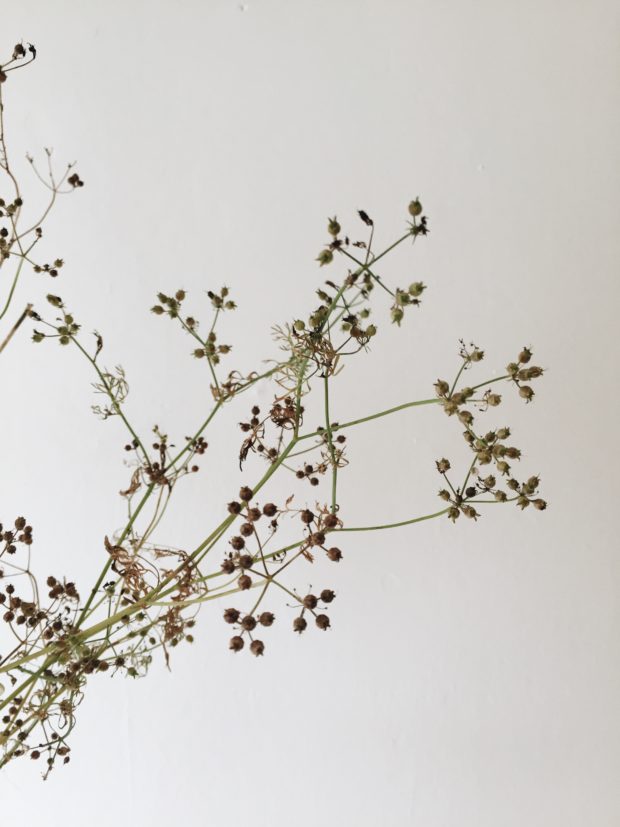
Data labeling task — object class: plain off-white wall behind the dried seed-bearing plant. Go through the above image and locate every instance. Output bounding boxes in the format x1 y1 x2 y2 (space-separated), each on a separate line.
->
0 0 620 827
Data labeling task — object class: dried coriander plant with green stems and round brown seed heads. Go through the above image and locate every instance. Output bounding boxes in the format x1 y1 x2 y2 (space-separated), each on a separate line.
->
0 44 546 776
